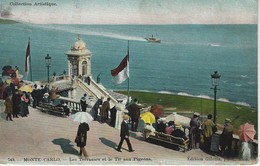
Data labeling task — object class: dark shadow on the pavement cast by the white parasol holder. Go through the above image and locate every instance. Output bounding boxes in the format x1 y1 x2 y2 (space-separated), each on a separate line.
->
52 138 79 155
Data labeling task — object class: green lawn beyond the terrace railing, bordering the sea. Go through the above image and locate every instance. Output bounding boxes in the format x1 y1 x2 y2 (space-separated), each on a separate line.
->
118 91 257 130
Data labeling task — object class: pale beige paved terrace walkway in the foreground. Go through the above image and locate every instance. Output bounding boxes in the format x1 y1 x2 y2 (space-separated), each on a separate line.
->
0 106 256 165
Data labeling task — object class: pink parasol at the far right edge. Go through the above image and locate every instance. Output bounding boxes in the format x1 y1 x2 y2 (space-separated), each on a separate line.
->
239 123 256 142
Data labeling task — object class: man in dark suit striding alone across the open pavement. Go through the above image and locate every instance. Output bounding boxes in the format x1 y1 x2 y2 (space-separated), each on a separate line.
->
116 115 134 152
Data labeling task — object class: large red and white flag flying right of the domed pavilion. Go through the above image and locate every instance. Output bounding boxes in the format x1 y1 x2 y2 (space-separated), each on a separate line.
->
111 55 129 84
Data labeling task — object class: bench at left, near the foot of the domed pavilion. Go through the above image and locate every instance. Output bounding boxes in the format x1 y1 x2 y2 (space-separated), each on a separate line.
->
39 102 65 117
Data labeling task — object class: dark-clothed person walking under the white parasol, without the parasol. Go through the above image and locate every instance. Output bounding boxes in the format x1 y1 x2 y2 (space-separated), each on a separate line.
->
75 122 89 157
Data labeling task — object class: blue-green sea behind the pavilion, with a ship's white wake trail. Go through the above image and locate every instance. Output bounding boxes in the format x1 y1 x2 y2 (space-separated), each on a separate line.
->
0 23 257 108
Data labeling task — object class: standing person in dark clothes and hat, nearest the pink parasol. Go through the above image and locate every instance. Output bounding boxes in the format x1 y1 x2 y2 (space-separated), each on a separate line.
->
220 118 234 157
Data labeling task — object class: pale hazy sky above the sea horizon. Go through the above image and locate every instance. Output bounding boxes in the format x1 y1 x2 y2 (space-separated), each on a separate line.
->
0 0 258 24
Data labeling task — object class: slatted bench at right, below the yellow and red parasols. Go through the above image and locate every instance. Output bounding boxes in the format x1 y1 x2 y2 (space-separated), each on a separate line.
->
144 129 189 152
